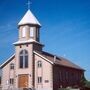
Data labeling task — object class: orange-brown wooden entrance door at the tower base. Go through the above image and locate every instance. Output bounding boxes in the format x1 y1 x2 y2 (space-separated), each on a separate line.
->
18 75 28 88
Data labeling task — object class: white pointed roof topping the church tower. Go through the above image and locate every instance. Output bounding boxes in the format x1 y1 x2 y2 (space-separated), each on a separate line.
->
18 10 41 26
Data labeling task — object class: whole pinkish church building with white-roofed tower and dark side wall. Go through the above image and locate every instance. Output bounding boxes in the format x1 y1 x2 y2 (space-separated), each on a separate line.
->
0 10 84 90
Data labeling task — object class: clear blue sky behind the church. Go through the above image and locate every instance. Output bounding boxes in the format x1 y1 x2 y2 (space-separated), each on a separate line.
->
0 0 90 80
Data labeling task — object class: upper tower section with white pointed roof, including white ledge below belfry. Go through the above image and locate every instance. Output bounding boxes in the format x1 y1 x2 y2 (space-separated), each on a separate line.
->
14 9 43 49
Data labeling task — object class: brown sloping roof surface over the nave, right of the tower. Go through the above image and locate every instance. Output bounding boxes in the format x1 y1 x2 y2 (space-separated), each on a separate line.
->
34 51 84 71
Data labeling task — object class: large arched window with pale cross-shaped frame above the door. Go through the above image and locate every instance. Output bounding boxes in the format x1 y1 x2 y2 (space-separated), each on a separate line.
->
19 50 28 68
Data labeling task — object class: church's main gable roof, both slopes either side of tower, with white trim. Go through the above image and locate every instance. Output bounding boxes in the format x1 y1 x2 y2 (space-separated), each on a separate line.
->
0 51 84 71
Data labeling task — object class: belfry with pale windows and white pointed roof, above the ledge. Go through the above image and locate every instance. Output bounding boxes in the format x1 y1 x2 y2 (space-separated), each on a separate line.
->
18 10 41 42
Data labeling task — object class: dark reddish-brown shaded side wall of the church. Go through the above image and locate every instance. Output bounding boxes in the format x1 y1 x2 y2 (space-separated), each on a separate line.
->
53 65 83 90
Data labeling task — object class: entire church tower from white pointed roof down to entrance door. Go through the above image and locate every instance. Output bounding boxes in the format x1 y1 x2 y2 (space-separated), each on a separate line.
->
14 9 43 88
